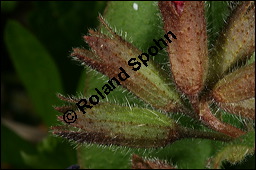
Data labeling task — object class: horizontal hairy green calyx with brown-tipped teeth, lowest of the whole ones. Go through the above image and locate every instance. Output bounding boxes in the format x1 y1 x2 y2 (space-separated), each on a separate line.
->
53 103 179 148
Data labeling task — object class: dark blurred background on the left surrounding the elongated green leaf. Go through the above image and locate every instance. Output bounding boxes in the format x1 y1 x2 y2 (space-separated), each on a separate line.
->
1 1 106 168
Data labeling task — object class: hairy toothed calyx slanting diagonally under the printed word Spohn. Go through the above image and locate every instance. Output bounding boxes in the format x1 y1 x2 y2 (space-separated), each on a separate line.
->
71 15 182 111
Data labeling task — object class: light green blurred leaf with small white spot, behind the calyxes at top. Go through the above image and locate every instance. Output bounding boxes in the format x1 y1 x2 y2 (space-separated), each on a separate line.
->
103 1 169 65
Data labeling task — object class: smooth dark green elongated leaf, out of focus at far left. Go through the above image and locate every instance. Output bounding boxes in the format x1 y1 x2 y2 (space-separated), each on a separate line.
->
5 20 62 126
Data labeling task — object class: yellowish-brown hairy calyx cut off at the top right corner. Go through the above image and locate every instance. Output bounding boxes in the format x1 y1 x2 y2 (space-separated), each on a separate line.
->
209 1 255 82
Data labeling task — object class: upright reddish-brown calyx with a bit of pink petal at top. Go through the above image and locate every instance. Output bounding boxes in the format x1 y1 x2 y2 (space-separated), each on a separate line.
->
159 1 208 96
